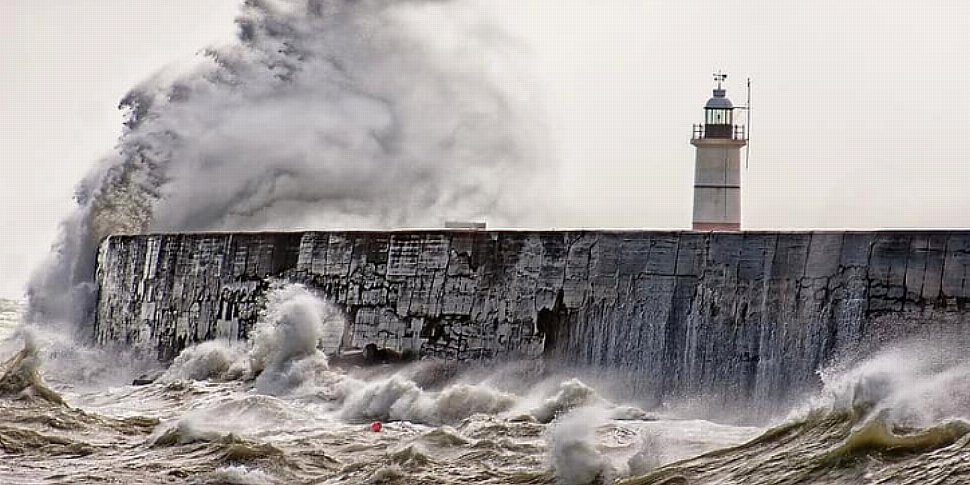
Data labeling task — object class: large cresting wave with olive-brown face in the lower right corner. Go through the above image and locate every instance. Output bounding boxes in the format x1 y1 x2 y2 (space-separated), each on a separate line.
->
623 342 970 485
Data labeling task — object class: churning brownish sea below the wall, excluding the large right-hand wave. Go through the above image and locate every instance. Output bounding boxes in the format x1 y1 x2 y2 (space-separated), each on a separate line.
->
0 289 760 484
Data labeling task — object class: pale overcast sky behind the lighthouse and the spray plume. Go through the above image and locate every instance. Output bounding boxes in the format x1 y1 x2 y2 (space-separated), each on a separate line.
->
0 0 970 296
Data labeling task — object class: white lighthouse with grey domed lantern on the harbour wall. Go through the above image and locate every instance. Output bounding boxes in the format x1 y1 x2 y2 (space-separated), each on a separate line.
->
690 73 748 231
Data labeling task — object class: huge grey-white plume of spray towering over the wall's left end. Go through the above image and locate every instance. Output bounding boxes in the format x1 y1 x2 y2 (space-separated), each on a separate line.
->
28 0 545 323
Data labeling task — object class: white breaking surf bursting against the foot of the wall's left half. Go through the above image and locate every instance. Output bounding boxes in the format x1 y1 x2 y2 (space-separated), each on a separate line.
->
160 285 516 424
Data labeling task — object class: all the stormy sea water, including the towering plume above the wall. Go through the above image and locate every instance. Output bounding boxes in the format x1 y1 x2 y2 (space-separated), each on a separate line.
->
9 0 970 485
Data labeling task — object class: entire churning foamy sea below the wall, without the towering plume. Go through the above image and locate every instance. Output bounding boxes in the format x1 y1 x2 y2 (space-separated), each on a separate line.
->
0 288 970 485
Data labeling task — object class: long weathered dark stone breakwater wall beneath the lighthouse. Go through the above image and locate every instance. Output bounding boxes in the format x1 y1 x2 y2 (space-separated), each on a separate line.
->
94 230 970 402
